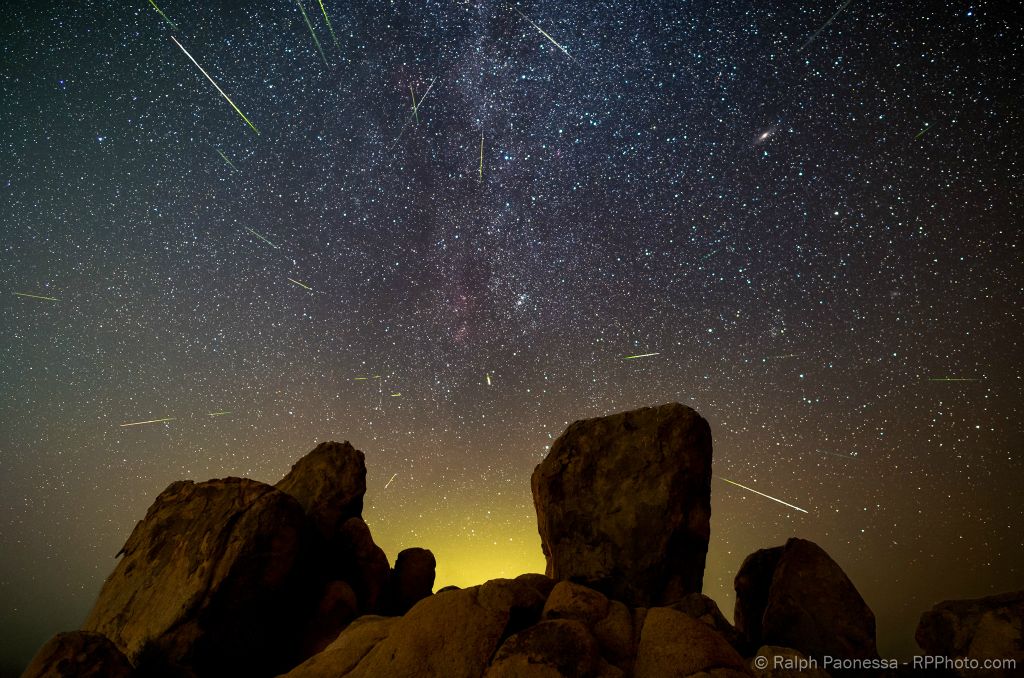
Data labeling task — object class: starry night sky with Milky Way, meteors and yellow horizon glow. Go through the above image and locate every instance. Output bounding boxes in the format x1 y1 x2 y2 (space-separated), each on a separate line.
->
0 0 1024 672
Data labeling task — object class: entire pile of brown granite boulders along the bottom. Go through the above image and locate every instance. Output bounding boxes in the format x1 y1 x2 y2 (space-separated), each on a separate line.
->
24 404 1024 678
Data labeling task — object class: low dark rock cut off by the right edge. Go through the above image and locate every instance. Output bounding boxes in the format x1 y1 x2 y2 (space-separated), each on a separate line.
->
915 591 1024 676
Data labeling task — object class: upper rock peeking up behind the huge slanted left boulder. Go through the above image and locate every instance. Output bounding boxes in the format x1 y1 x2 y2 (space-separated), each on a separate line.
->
274 441 367 542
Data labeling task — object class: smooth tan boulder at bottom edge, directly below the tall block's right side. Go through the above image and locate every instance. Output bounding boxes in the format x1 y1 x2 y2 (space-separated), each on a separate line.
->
633 607 748 678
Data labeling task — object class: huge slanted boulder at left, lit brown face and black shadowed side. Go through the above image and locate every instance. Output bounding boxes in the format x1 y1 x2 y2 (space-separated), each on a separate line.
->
84 478 309 676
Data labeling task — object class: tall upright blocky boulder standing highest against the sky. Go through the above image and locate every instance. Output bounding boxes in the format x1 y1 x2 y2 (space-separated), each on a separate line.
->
531 402 712 606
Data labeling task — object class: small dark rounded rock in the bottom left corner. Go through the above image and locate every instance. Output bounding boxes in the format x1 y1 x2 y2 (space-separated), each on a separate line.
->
22 631 135 678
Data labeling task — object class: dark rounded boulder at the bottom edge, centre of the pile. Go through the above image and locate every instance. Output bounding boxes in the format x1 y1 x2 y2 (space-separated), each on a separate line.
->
483 620 602 678
